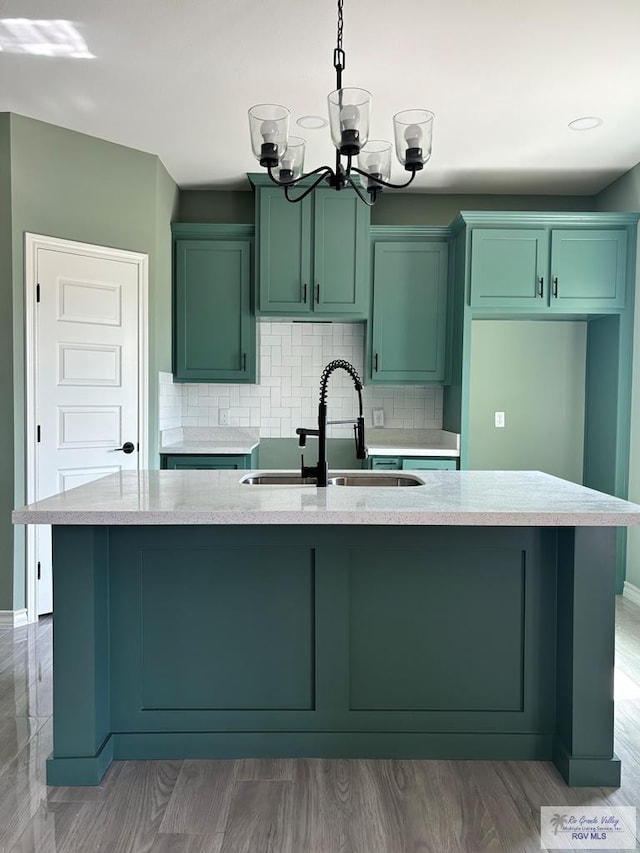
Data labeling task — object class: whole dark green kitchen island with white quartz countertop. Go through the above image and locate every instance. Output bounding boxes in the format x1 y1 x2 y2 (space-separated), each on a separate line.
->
13 471 640 786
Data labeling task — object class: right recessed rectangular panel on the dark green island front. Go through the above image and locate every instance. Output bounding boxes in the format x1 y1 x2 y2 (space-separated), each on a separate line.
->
349 546 525 712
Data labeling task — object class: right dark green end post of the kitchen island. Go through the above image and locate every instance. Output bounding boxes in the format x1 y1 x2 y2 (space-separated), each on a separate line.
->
554 527 620 787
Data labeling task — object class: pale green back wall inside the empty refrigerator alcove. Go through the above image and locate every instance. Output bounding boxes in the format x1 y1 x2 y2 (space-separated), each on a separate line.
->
469 320 586 483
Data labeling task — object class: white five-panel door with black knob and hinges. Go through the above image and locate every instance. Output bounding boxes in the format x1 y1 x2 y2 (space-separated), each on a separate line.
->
30 236 148 615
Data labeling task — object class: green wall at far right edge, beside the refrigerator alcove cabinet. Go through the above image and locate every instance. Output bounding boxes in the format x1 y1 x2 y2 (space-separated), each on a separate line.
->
596 163 640 589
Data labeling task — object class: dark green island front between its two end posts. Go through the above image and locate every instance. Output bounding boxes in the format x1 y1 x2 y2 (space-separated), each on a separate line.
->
106 525 556 744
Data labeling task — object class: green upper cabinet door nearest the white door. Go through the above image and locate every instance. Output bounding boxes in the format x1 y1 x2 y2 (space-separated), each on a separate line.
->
174 240 255 382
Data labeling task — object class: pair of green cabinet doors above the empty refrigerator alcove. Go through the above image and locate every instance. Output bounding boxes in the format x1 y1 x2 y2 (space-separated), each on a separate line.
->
470 227 627 314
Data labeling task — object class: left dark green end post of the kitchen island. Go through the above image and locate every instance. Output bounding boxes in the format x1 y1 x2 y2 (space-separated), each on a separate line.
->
47 526 113 785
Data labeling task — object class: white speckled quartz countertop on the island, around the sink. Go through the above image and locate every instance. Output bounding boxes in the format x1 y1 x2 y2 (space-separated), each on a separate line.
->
13 470 640 527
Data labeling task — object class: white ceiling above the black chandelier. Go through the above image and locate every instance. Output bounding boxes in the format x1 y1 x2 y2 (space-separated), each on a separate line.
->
0 0 640 194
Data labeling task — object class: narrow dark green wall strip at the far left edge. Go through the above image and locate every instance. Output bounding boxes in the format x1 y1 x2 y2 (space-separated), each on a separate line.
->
0 113 14 610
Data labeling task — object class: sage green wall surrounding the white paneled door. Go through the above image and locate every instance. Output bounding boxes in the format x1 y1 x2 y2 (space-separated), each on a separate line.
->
0 114 177 610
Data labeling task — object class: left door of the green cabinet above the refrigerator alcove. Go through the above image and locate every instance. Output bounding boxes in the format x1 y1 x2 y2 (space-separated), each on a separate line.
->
471 228 549 309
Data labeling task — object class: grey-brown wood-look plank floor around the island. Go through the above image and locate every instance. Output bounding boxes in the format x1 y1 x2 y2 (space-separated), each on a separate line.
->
0 599 640 853
